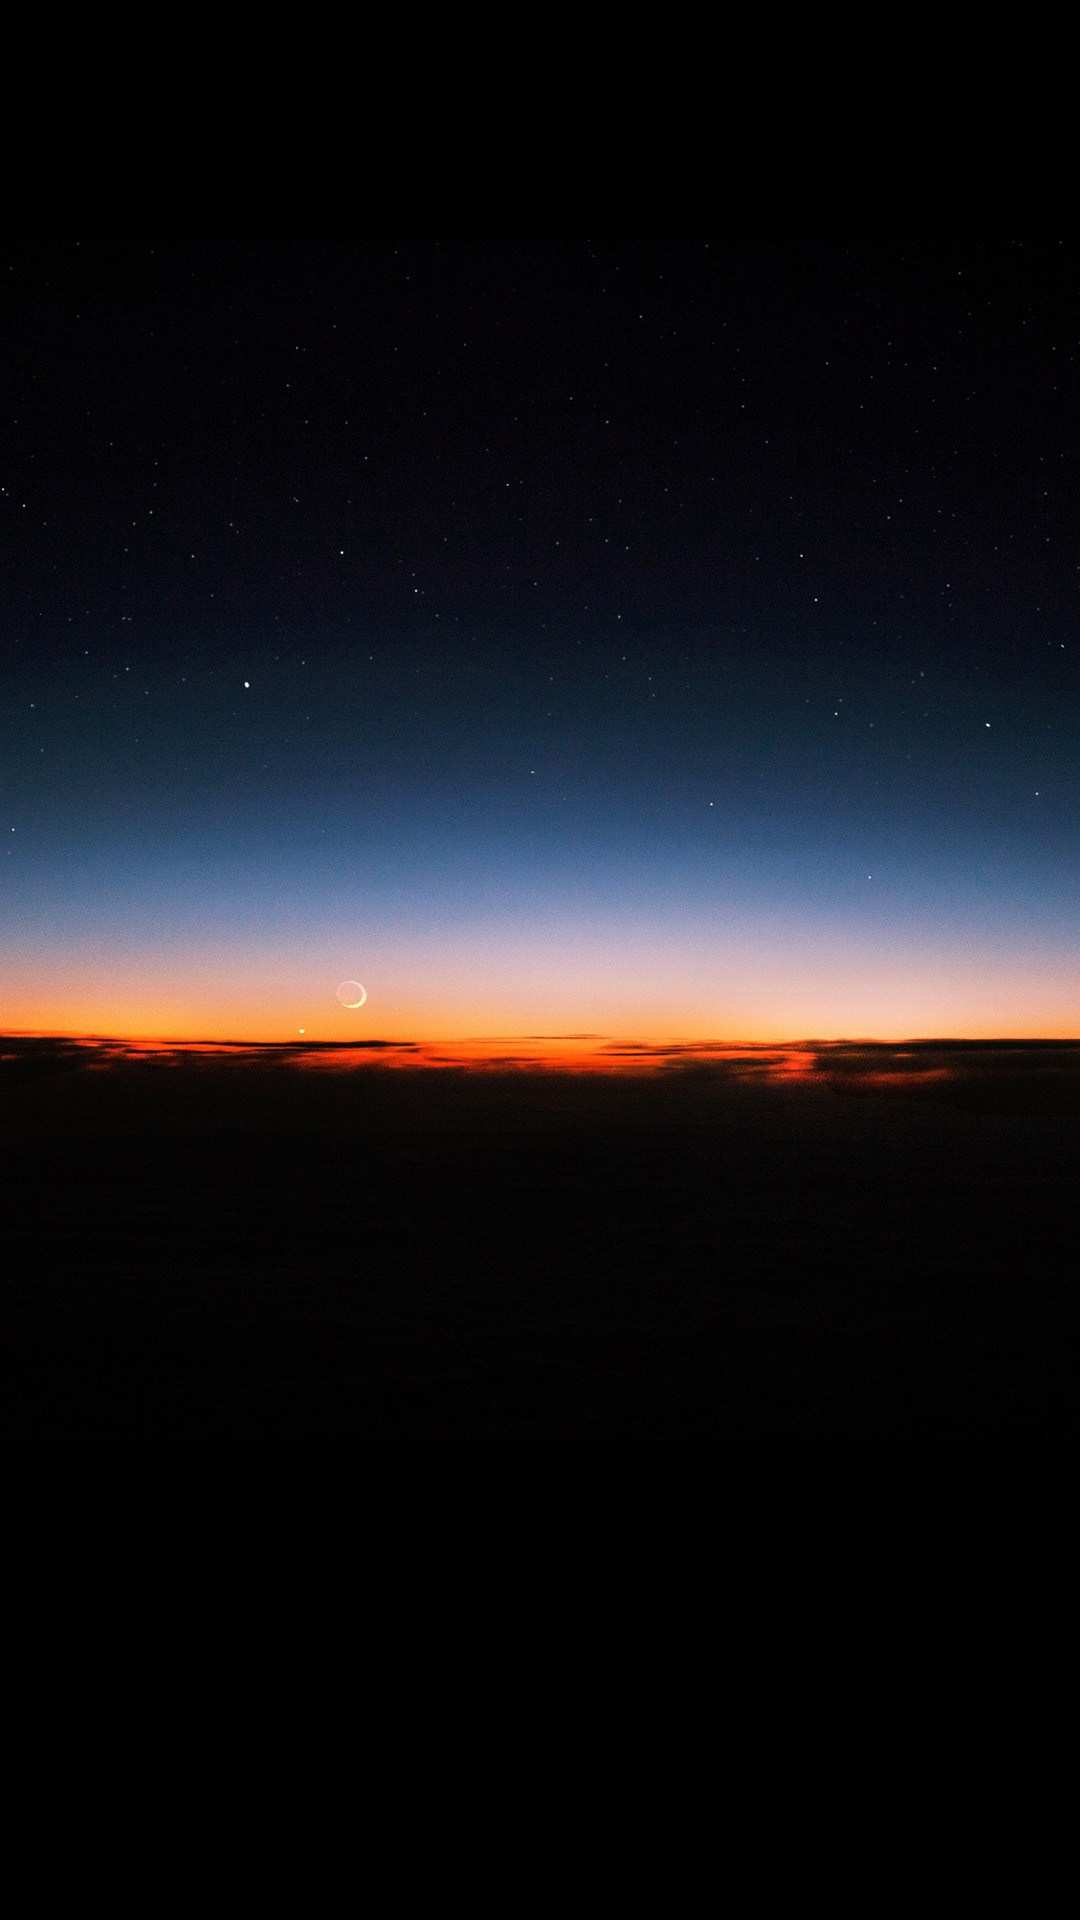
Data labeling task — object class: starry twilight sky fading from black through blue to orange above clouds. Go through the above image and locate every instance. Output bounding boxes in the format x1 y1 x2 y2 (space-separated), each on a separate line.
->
0 245 1080 1041
